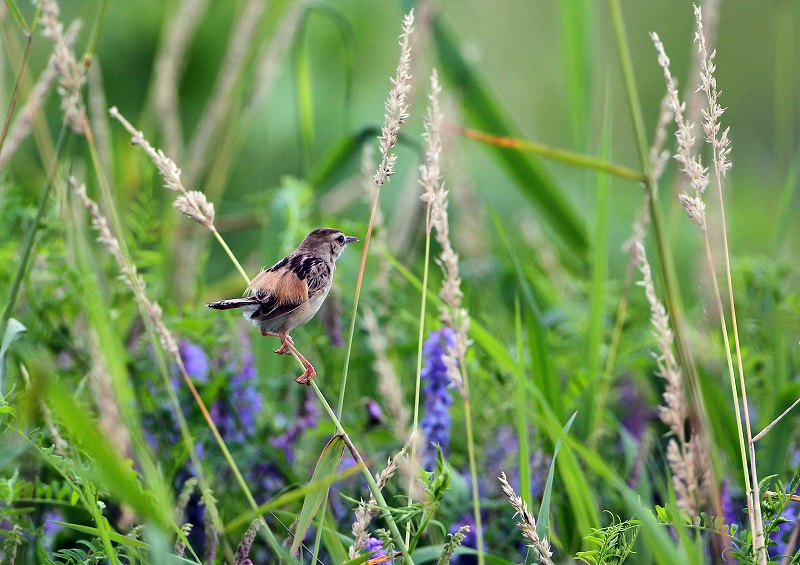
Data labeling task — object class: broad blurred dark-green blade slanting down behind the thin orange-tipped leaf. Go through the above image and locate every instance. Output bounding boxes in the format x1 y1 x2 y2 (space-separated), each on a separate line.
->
433 18 589 259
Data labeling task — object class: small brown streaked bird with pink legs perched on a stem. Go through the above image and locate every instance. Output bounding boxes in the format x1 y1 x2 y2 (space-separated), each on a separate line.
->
206 228 358 385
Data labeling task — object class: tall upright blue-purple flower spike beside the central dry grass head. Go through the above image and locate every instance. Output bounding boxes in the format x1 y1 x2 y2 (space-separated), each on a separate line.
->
420 328 455 469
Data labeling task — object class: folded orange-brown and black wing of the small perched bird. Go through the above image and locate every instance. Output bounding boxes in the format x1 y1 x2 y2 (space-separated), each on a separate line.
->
245 255 309 320
